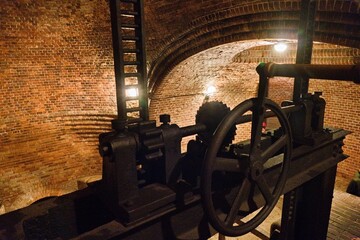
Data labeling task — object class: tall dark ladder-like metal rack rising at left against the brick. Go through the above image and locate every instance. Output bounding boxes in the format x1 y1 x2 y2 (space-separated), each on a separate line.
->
110 0 149 130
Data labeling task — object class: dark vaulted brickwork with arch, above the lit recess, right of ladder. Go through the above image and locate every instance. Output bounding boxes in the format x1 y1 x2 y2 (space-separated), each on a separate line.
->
144 0 360 92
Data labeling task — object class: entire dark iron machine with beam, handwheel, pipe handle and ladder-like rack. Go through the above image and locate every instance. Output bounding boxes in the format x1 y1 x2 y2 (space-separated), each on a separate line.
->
0 0 360 240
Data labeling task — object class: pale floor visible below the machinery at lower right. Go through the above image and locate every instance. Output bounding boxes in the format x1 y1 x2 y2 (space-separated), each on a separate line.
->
210 174 360 240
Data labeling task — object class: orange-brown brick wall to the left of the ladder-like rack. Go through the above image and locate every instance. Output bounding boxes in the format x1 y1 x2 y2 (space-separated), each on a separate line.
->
0 0 115 211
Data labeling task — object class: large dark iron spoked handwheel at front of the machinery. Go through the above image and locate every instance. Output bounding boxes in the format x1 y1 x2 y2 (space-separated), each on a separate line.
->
201 98 292 236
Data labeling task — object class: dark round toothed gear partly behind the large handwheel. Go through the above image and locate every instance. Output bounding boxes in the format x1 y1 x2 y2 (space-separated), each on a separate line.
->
195 101 236 146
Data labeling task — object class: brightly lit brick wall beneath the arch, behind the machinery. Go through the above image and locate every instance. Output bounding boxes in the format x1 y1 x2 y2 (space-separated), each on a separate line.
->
149 41 360 180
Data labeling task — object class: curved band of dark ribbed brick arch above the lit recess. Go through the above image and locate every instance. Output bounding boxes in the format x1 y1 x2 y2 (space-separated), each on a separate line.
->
149 0 360 93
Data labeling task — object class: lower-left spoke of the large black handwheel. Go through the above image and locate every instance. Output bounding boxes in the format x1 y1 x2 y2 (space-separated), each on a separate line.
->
225 178 251 226
